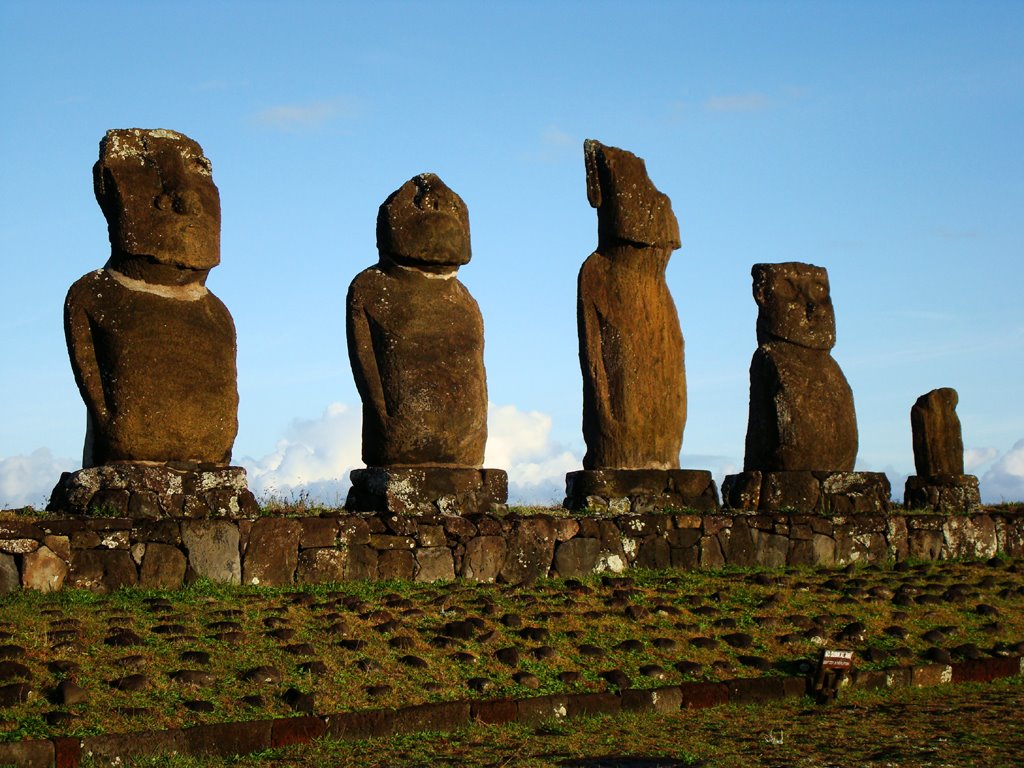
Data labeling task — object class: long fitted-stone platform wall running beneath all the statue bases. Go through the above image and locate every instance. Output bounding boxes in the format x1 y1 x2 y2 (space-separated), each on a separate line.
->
0 511 1024 592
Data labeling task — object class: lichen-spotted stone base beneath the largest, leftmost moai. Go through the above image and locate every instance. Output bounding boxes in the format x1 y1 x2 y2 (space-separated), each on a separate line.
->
46 462 259 519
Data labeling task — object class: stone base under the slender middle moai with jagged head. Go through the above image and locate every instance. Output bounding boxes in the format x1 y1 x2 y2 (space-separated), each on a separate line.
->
562 469 719 514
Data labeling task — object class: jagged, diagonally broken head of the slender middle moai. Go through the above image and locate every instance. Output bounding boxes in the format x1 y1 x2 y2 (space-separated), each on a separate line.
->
583 138 679 251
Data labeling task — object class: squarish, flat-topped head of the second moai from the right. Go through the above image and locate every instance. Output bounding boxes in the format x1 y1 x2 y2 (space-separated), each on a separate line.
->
751 261 836 349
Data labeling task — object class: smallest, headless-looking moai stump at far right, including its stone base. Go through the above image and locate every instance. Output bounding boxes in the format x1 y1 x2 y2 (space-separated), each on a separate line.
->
903 387 981 512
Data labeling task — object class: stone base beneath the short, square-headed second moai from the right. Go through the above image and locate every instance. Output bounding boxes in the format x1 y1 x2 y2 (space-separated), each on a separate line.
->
722 470 892 515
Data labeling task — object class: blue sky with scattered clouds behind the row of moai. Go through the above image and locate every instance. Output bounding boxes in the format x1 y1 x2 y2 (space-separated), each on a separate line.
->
0 0 1024 506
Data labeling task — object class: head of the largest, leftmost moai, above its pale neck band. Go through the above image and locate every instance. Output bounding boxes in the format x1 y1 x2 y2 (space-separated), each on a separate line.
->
92 128 220 282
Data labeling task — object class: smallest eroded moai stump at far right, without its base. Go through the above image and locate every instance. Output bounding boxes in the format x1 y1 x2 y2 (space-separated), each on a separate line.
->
910 387 964 476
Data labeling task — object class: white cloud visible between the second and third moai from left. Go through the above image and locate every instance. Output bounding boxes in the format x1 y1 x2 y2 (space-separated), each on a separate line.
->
483 403 583 506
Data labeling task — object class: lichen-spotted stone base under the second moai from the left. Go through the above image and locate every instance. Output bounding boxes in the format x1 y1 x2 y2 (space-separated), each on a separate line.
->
345 467 509 515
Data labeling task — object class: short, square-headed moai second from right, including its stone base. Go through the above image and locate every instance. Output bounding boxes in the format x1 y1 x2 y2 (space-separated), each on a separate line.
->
723 261 890 512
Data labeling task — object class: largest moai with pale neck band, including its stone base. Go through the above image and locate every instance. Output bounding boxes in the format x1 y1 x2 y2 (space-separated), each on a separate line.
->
51 128 255 516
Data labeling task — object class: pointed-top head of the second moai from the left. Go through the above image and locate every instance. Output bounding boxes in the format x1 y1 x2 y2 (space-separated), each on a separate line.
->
377 173 471 272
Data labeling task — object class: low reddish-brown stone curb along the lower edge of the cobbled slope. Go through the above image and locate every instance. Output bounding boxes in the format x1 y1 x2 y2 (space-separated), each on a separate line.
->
0 656 1024 768
